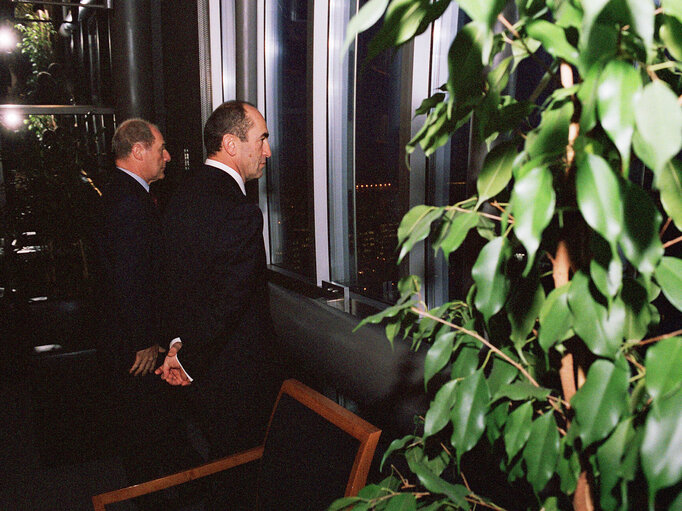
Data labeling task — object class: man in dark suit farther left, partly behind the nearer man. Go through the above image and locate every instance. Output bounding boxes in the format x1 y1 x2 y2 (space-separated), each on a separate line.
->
94 119 183 498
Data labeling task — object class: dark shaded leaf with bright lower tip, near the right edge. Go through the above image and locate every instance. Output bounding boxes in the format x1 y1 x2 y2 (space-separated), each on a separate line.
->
620 180 660 276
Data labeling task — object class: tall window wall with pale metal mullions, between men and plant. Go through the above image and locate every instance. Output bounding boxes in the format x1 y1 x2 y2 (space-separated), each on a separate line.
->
227 0 478 305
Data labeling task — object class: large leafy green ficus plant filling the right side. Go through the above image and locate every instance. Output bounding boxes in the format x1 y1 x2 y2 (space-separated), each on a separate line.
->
331 0 682 511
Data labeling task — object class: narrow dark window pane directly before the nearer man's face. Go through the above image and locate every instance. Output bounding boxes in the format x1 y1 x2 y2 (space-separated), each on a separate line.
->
265 0 315 278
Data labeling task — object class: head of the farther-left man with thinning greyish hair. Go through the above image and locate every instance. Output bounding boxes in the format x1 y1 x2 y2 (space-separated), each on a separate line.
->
111 119 170 183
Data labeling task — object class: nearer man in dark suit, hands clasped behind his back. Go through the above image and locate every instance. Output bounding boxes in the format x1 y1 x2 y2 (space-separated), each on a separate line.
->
156 101 281 457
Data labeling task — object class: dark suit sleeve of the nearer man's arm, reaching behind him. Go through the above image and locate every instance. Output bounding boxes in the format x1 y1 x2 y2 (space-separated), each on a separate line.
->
166 204 264 377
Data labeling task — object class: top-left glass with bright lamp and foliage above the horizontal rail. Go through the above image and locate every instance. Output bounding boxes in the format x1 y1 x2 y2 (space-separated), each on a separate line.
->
0 3 111 105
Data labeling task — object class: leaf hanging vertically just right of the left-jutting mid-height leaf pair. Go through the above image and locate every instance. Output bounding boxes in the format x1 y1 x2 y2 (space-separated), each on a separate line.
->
471 238 509 321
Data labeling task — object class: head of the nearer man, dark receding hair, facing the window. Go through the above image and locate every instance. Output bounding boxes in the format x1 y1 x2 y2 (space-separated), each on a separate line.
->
204 101 272 182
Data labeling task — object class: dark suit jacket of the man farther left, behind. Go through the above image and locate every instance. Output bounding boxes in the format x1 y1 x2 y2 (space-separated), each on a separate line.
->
94 169 167 371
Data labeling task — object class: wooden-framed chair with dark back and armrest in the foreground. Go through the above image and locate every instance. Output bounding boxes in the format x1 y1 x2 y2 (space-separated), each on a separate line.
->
92 379 381 511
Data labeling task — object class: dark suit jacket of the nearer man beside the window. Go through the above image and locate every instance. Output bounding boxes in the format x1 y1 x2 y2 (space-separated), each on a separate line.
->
163 165 273 378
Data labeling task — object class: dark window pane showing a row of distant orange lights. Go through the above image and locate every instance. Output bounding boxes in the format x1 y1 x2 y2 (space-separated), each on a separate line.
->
351 2 408 302
